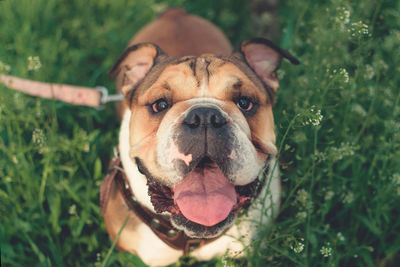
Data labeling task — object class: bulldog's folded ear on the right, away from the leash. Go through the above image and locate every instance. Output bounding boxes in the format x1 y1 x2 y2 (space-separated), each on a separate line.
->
240 38 300 92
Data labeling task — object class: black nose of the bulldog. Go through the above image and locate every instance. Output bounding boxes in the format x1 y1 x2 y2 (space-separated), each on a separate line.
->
183 107 227 129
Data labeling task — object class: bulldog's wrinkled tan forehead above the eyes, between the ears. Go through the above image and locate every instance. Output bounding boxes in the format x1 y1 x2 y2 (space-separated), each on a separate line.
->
135 54 270 101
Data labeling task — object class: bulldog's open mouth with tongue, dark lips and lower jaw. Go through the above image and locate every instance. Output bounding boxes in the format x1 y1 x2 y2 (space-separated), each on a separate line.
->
142 157 261 238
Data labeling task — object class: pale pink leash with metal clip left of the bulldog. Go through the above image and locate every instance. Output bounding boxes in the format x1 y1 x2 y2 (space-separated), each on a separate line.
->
0 74 124 107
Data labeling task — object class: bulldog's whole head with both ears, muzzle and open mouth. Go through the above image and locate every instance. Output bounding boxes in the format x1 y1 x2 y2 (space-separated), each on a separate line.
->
112 39 296 238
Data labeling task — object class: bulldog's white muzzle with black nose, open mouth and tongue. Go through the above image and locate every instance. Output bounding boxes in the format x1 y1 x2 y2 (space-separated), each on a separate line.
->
149 101 264 238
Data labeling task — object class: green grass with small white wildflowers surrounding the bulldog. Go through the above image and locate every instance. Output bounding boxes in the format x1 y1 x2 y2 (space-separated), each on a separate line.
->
0 0 400 266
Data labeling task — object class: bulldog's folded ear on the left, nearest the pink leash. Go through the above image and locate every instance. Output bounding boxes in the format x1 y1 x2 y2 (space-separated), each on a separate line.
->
108 43 164 96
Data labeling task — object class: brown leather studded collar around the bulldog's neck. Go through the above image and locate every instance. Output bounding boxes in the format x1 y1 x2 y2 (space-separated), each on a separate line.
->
100 157 221 255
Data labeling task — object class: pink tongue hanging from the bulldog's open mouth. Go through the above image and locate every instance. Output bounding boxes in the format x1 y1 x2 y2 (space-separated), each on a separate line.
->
174 166 236 226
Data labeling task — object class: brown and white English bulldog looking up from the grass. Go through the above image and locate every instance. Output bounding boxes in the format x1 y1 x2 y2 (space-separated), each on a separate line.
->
101 9 298 266
